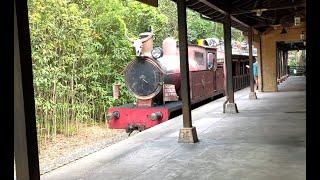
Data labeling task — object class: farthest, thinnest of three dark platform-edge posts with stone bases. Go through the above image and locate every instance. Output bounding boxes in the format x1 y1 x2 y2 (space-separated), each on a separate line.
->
248 27 257 99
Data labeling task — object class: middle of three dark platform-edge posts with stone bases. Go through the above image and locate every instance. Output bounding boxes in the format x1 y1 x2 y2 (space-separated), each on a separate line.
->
223 13 238 113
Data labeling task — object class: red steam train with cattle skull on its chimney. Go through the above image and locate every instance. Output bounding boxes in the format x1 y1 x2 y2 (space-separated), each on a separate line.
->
106 32 256 133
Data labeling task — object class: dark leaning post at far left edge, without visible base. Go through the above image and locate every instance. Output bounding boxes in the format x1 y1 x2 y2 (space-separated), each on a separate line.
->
14 1 40 180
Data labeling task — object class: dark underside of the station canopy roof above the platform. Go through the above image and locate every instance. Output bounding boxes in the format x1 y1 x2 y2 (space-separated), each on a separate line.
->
173 0 306 32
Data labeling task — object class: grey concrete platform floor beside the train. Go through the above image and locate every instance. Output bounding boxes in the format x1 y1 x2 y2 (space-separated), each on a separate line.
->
41 77 306 180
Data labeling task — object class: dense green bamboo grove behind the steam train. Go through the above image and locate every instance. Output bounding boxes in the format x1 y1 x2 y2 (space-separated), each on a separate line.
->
28 0 244 144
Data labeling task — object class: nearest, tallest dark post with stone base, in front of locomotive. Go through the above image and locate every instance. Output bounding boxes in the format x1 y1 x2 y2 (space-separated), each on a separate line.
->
177 0 198 143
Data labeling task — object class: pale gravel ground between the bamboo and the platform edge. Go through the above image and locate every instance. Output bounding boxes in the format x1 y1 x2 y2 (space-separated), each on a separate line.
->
14 126 138 179
